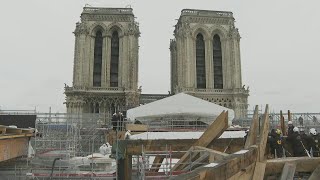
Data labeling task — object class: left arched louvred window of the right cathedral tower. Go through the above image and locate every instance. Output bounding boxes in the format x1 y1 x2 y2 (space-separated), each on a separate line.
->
196 33 206 89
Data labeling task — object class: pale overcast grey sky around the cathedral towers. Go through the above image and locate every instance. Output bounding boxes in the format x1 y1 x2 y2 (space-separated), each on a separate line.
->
0 0 320 112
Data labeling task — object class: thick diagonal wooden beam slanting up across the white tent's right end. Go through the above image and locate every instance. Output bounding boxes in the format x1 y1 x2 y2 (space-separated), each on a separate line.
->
172 111 228 171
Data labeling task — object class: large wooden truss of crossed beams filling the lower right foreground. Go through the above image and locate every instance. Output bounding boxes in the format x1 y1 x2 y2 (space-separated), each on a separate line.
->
172 105 320 180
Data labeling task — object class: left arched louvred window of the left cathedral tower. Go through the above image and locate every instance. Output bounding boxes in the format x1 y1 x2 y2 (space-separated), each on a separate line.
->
93 31 103 87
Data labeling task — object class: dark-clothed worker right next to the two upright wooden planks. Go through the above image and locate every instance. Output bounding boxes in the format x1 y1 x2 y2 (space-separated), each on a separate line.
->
269 129 283 158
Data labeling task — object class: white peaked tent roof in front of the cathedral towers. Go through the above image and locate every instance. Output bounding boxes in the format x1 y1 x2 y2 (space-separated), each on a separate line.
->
127 93 234 122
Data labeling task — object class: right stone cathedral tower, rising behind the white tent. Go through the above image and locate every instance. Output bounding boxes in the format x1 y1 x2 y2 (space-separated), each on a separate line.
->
170 9 249 118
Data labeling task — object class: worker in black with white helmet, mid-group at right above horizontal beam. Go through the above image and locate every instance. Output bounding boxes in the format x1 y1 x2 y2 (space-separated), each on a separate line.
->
287 127 309 157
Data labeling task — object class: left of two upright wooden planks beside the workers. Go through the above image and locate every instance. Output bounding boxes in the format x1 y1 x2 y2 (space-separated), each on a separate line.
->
244 105 259 148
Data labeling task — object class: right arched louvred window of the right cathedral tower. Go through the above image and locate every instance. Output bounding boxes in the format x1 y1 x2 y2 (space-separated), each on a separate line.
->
213 34 223 89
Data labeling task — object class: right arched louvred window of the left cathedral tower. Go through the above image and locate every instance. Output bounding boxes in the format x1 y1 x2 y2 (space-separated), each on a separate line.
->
110 31 119 87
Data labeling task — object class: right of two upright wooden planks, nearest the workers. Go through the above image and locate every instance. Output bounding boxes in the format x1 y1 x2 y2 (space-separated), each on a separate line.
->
257 104 270 162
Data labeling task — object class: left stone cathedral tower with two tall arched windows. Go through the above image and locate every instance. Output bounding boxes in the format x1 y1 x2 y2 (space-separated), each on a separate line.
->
65 7 140 114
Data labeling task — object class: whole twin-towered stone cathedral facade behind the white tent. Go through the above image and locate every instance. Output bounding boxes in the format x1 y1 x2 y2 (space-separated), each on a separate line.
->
65 7 249 118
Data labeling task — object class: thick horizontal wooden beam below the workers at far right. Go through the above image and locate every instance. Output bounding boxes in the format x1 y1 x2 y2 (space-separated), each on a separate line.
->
265 157 320 175
